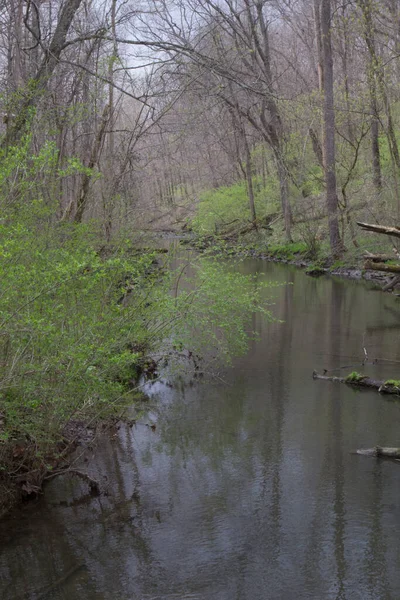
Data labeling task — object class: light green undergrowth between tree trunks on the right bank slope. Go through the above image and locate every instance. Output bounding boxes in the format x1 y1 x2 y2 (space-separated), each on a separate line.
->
186 126 400 270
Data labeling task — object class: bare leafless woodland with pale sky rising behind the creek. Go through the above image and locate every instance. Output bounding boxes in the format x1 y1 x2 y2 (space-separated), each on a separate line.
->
0 0 400 255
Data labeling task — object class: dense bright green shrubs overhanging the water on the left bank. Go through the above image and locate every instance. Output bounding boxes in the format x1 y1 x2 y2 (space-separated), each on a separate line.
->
0 138 276 509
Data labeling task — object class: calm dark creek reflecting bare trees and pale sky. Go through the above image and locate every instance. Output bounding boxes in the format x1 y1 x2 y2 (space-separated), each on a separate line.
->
0 259 400 600
